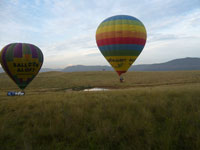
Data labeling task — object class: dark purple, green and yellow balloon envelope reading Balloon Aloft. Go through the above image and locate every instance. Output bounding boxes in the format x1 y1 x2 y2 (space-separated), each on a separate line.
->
0 43 43 90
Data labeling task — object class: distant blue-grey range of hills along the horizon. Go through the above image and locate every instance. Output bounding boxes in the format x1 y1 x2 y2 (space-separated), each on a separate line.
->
0 57 200 73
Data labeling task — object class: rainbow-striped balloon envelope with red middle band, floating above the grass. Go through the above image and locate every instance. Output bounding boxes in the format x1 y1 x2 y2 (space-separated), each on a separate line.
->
96 15 147 76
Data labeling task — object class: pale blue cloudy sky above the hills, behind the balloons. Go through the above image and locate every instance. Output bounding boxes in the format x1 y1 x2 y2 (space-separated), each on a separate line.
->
0 0 200 68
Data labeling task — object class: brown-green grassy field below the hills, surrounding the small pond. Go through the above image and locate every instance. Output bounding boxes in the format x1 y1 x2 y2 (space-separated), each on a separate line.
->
0 71 200 150
